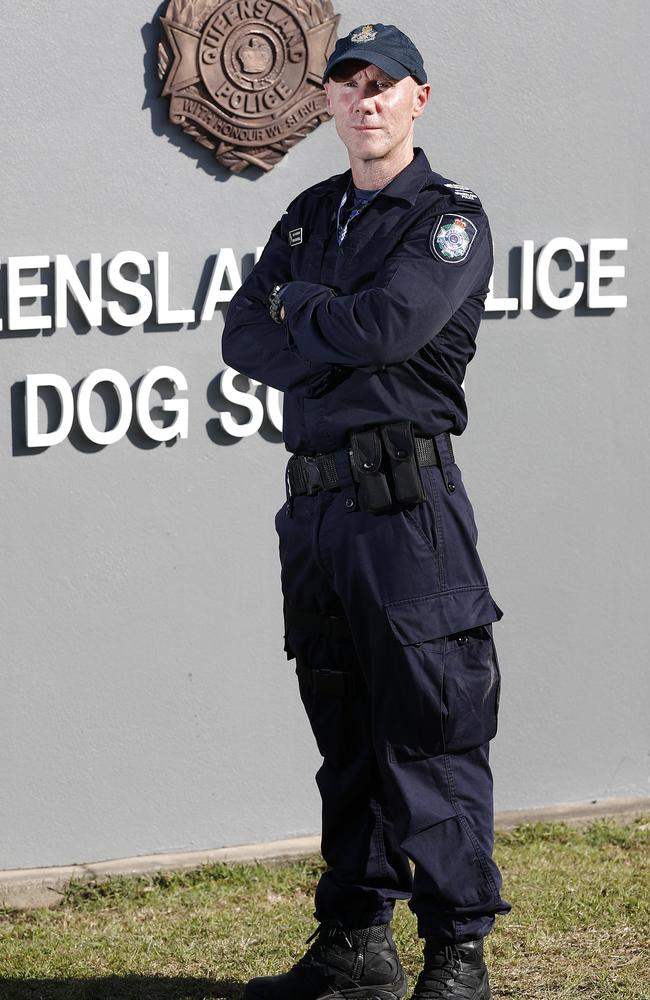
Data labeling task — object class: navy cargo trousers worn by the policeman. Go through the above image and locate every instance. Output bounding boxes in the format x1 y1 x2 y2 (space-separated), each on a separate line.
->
275 435 510 943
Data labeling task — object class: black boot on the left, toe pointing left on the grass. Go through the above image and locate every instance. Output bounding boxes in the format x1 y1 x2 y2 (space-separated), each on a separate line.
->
244 921 406 1000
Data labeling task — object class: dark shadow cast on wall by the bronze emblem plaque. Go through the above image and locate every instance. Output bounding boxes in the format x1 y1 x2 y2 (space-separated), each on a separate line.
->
141 0 264 181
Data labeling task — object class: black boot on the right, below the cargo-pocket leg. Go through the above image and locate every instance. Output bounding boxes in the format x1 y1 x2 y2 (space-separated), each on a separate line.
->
413 940 492 1000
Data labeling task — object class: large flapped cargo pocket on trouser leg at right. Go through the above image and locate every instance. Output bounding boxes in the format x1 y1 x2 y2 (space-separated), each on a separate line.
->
385 587 502 761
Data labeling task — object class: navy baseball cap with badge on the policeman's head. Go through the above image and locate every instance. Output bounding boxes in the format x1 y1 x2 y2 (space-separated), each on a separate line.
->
323 24 427 83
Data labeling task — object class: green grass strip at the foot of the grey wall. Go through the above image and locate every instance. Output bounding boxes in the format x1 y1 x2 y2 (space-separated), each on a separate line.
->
0 817 650 1000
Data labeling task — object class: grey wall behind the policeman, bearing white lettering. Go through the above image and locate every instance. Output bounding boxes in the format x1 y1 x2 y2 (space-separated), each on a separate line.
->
0 0 650 868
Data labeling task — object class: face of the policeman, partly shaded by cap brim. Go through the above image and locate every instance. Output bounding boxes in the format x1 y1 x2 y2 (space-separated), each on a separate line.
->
325 60 430 160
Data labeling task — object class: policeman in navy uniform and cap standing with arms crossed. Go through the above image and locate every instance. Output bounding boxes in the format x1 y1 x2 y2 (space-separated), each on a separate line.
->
223 24 509 1000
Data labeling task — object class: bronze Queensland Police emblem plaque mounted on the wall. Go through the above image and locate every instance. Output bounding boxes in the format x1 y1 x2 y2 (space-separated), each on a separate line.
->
158 0 339 173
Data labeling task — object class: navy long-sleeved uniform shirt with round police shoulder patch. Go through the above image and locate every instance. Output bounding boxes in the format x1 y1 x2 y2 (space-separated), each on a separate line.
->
223 149 493 455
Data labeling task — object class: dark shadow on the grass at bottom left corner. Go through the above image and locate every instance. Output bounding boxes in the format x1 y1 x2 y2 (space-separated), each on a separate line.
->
0 975 245 1000
